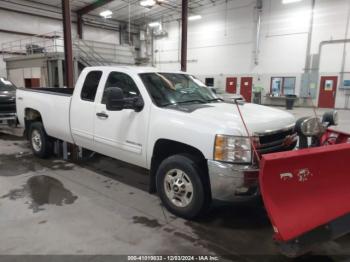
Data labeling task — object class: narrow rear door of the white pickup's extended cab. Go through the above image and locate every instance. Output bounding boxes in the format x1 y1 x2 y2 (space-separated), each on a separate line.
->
69 70 102 150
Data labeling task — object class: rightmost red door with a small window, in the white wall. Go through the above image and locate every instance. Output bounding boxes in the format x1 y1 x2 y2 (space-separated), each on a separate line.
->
318 76 338 108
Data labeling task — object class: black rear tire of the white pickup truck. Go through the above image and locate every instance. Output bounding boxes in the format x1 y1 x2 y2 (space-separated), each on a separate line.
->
29 122 53 158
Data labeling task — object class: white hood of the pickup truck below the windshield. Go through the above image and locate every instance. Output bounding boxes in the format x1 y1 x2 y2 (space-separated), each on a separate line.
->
167 103 296 135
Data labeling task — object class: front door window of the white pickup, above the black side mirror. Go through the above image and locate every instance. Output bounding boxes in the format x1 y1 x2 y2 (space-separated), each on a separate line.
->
101 72 140 104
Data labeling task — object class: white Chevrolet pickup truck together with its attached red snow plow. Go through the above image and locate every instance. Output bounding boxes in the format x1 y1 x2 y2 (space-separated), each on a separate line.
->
16 66 350 256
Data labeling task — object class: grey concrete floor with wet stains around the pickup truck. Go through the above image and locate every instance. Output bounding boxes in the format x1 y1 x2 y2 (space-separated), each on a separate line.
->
0 108 350 261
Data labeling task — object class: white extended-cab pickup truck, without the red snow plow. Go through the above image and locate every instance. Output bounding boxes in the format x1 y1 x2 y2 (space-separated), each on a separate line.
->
16 66 297 218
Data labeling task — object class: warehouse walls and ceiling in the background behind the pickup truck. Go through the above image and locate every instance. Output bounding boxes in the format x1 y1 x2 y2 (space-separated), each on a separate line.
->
0 0 350 109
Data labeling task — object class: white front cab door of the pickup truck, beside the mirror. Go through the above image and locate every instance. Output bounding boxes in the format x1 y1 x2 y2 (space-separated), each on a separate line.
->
94 71 149 167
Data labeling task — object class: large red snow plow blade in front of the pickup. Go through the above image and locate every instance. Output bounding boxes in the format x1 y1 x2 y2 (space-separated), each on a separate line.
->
260 134 350 256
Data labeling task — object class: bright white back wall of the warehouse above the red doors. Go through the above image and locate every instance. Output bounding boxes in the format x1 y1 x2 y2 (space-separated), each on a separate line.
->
155 0 350 108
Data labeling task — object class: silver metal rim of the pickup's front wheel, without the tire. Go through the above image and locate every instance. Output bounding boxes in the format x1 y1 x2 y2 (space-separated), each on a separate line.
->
164 169 193 207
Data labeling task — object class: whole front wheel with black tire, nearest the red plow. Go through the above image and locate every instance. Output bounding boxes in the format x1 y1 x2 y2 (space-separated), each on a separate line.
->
156 155 210 219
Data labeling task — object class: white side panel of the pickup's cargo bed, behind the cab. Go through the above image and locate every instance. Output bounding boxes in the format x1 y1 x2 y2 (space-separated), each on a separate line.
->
16 88 74 143
